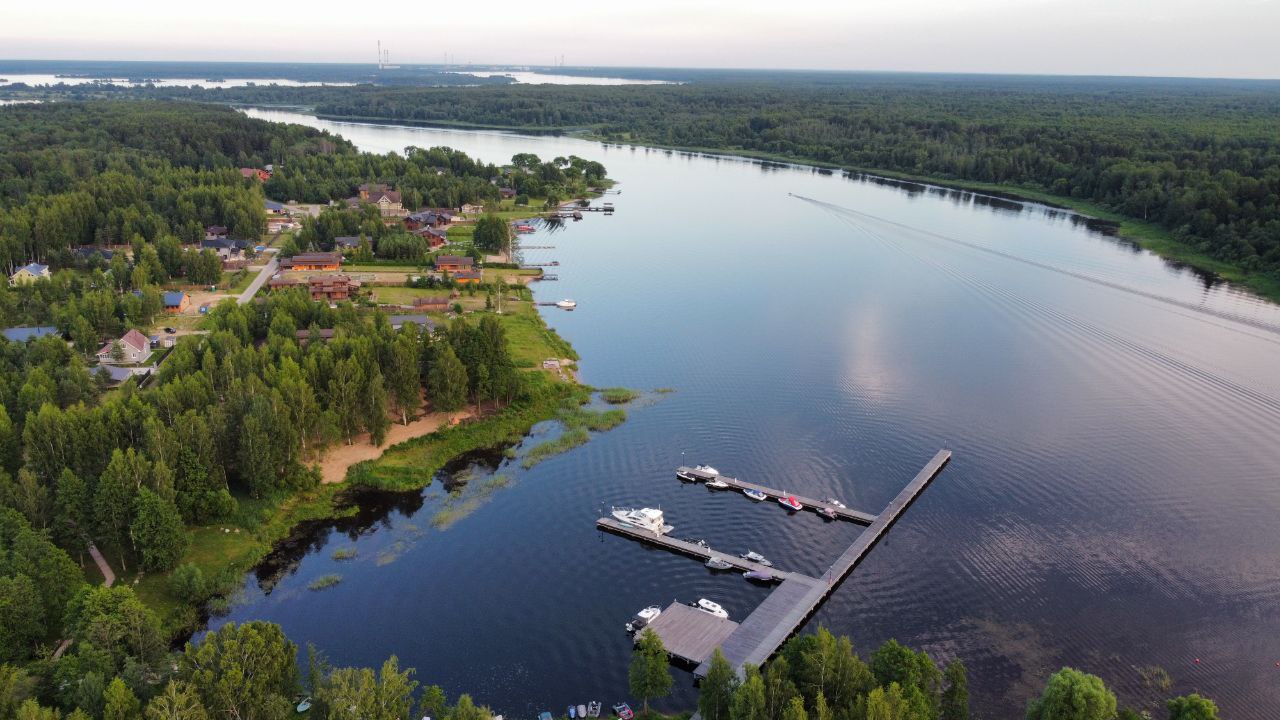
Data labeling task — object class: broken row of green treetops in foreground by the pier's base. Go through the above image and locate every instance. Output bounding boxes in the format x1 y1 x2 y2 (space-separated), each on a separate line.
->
628 628 1217 720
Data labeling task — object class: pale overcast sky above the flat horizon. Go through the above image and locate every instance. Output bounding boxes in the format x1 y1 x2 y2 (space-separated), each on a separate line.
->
0 0 1280 78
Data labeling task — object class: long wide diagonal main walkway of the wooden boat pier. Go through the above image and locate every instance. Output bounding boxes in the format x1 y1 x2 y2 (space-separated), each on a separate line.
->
694 450 951 678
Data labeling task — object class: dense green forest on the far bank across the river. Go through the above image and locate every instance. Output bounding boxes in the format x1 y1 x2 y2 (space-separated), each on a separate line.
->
42 73 1280 292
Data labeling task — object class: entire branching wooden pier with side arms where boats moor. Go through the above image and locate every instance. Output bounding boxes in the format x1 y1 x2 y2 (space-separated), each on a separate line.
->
595 450 951 678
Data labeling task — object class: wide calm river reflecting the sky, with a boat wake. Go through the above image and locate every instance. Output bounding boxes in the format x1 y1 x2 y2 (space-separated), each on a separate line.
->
214 110 1280 719
